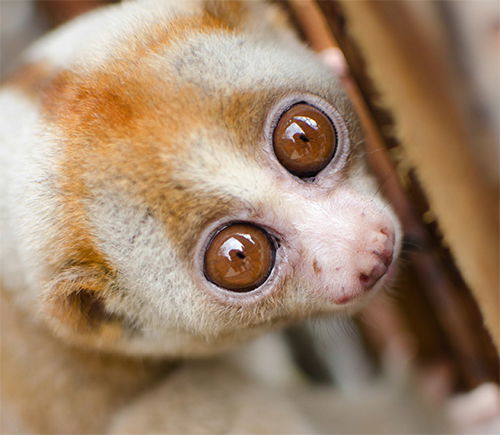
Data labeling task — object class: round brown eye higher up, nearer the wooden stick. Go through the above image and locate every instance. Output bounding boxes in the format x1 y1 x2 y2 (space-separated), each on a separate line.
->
273 103 336 177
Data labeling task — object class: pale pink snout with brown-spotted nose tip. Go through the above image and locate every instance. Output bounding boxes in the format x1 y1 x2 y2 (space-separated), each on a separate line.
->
280 187 401 308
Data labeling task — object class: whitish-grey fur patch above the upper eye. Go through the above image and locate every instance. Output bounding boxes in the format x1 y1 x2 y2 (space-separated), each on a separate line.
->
158 32 335 95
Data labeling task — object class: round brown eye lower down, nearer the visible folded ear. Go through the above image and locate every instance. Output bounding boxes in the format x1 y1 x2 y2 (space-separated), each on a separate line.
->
204 224 274 292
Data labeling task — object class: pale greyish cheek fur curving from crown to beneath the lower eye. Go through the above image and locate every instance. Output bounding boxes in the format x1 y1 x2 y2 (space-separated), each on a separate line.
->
87 192 279 353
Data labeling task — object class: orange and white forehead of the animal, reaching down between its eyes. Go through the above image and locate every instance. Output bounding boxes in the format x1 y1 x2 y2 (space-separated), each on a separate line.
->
37 3 357 268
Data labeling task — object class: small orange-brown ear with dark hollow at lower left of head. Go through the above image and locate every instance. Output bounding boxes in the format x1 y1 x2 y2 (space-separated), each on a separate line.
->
42 265 122 341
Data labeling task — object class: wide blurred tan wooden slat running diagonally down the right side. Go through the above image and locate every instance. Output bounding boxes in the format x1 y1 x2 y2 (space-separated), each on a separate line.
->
339 0 500 345
